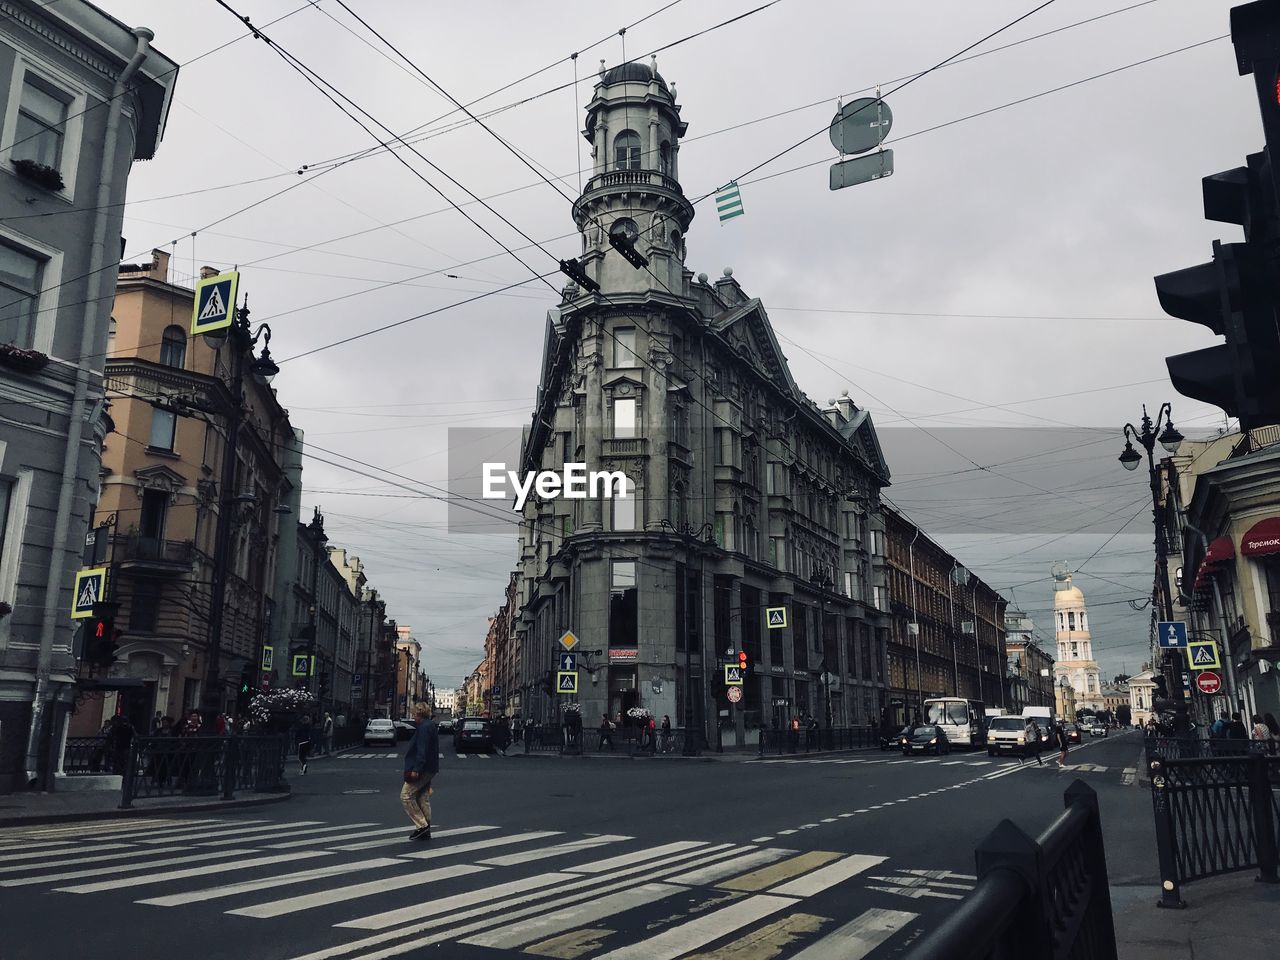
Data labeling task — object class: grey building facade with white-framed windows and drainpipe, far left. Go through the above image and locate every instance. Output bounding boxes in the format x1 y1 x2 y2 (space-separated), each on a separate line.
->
0 0 178 792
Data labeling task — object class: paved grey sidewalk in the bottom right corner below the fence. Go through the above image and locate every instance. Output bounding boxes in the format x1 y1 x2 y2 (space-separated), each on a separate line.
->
1111 870 1280 960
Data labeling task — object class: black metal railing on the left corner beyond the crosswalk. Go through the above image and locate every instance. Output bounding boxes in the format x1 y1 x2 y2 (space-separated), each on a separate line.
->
120 736 284 808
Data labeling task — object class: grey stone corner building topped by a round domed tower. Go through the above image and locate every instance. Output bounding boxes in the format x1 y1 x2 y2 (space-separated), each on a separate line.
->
504 63 890 744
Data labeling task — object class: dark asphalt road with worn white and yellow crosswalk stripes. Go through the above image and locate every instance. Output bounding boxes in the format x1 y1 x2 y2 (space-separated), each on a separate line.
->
0 733 1155 960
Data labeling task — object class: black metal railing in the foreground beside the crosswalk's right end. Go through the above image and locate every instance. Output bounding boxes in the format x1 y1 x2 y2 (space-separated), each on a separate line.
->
906 780 1116 960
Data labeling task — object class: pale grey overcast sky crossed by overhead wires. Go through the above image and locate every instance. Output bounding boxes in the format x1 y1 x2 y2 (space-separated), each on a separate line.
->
101 0 1262 686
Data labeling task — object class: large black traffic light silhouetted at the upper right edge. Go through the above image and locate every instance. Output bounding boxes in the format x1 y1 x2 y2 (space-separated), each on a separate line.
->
1155 0 1280 429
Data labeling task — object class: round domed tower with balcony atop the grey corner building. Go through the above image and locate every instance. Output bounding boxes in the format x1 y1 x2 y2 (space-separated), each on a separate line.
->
573 58 694 297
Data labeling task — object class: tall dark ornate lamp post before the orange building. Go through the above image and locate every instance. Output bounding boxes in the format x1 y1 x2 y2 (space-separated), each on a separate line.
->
204 298 280 722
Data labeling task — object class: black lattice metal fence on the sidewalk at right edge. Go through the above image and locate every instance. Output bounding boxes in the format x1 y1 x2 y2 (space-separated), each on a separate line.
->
1147 740 1280 908
